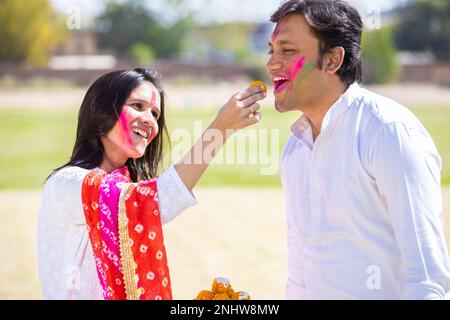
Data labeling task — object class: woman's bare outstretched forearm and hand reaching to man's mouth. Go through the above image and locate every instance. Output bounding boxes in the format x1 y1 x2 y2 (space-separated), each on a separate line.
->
175 86 266 190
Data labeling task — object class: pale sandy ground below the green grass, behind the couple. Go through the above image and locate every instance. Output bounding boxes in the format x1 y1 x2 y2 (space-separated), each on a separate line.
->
0 187 450 300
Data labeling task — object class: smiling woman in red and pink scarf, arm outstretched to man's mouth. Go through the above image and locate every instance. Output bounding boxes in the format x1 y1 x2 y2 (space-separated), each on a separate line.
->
38 69 265 299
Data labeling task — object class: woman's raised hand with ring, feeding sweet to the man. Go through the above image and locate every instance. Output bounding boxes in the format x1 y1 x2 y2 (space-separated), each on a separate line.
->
211 86 267 131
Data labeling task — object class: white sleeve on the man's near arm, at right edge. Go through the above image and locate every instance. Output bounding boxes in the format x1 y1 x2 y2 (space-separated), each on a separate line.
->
371 123 450 299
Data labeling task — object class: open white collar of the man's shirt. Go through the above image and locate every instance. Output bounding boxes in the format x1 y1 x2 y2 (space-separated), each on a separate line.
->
291 82 361 143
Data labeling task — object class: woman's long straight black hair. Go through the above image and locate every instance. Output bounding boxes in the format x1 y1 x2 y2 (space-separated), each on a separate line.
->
49 69 168 182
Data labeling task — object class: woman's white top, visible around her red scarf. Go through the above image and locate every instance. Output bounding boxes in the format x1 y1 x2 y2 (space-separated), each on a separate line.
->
37 166 196 300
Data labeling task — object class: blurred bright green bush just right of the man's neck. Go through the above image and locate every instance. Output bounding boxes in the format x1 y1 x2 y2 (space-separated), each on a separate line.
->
362 27 400 83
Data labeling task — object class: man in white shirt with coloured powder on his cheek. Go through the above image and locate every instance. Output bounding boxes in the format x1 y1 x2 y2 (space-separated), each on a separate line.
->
267 0 450 299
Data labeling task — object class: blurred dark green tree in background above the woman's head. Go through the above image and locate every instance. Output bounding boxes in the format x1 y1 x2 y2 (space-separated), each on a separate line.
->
96 0 193 59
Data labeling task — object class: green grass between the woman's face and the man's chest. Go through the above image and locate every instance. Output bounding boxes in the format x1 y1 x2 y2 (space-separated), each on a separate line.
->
168 110 299 187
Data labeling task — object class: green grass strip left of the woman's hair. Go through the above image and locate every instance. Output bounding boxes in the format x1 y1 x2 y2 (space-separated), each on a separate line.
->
0 110 76 189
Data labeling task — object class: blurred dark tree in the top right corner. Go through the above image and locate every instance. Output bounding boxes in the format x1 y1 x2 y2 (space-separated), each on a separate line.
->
394 0 450 61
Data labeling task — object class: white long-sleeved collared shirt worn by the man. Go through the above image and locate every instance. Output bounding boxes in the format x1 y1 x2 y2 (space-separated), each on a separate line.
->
281 84 450 299
